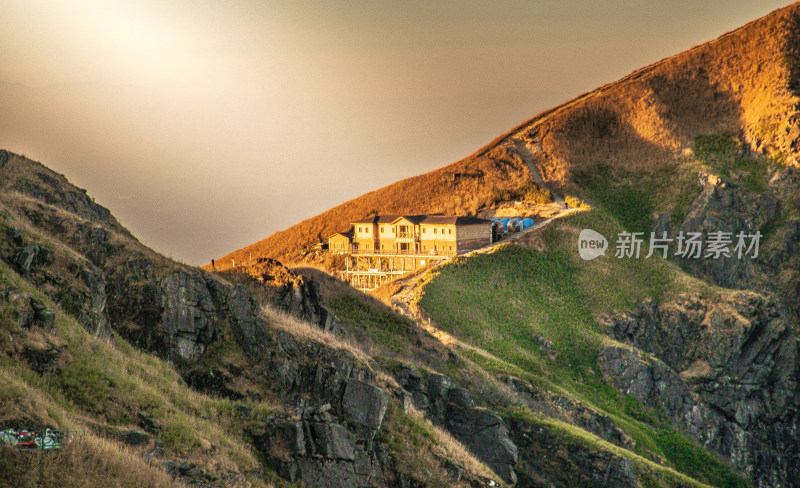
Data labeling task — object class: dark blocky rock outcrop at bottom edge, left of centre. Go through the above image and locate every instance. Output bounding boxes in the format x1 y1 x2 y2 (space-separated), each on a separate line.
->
251 331 390 488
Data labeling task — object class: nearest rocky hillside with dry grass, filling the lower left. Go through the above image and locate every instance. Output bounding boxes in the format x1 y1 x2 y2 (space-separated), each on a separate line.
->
0 151 507 487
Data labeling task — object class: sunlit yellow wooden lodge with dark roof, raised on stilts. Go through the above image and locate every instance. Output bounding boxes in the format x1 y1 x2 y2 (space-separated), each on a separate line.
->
328 215 493 290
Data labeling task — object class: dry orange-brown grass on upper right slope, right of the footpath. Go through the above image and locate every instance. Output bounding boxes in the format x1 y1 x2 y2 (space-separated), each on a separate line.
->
515 4 800 183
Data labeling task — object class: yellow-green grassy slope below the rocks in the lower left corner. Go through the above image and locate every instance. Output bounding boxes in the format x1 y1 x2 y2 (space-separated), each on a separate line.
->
0 262 278 486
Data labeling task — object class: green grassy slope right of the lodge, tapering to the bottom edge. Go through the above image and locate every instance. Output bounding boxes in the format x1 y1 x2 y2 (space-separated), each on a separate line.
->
419 210 743 486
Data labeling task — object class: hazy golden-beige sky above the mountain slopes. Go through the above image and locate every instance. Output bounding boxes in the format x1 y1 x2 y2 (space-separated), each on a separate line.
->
0 0 786 264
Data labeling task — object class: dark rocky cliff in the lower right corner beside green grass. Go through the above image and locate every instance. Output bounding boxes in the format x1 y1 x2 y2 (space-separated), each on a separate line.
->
600 292 800 487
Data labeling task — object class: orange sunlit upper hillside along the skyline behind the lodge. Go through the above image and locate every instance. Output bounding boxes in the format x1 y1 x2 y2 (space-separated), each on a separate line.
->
212 4 800 267
